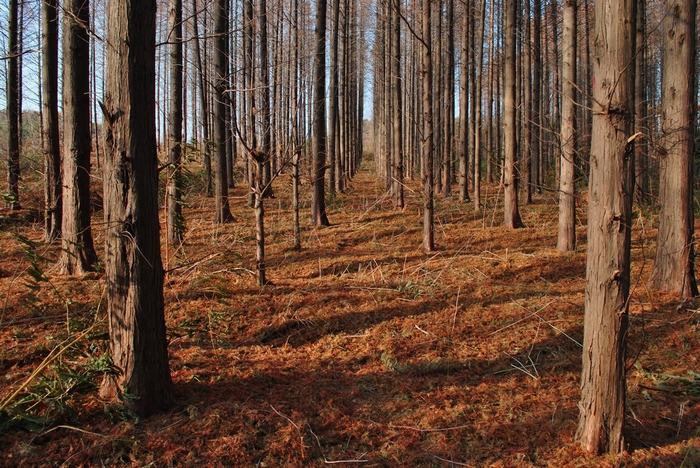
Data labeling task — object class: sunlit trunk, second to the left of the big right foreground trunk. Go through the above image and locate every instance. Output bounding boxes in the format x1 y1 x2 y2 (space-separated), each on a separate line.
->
503 0 524 229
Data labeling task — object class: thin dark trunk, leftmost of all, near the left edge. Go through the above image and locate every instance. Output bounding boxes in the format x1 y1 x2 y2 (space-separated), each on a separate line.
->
7 0 22 210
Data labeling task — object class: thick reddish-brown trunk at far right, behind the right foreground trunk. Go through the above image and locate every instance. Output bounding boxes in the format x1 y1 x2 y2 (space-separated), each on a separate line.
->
651 0 698 297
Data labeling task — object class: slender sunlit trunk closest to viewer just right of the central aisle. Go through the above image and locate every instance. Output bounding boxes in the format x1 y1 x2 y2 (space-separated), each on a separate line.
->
421 0 435 252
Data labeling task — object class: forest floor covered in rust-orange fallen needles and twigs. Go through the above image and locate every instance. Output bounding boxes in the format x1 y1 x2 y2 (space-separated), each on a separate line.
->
0 159 700 467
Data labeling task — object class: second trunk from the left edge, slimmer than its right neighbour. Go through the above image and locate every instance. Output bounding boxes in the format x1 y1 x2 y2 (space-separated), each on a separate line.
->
41 0 63 242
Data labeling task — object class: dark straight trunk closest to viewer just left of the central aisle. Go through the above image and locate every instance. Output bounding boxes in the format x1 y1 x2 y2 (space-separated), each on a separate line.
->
311 0 330 226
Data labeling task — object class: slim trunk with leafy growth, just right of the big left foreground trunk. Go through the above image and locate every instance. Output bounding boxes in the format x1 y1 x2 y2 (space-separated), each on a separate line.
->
167 0 185 245
